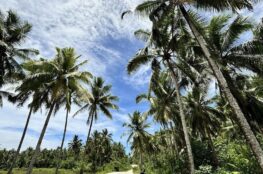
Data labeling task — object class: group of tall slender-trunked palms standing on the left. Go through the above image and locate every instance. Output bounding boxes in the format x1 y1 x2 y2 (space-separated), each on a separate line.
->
0 11 118 174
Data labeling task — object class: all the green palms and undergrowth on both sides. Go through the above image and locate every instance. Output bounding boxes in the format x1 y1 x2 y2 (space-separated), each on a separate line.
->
0 0 263 174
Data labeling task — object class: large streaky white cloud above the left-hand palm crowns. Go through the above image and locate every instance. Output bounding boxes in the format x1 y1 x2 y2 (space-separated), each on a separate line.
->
0 0 152 75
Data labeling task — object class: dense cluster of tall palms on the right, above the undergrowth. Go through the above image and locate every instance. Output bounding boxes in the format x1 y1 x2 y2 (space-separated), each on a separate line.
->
122 0 263 174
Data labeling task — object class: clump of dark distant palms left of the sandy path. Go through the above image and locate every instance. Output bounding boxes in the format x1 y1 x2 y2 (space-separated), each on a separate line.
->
69 129 126 173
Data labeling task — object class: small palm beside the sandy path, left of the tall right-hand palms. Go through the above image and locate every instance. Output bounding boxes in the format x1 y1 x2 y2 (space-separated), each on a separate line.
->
123 111 150 171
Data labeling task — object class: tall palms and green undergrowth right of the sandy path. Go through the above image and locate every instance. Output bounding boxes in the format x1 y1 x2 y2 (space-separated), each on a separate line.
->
122 0 263 174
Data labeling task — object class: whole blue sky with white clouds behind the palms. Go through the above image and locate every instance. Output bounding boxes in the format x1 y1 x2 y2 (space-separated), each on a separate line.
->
0 0 263 152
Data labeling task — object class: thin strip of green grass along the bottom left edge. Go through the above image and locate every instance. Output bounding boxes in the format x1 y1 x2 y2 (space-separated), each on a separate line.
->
0 168 75 174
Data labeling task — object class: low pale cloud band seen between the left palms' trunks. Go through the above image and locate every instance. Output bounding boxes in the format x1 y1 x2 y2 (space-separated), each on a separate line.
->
0 101 124 149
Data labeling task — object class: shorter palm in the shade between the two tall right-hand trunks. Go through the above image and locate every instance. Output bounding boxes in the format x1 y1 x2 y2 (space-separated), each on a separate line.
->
185 85 226 167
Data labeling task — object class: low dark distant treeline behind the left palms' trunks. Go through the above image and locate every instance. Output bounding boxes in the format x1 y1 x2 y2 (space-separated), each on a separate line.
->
0 129 129 173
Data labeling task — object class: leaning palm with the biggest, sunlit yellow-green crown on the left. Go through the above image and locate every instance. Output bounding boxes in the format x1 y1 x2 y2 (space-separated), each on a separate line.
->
23 48 91 174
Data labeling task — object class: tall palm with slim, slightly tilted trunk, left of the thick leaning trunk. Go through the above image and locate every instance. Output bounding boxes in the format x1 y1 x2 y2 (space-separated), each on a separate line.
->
127 13 197 173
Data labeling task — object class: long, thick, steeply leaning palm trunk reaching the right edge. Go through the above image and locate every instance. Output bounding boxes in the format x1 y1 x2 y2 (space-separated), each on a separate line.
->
180 4 263 171
